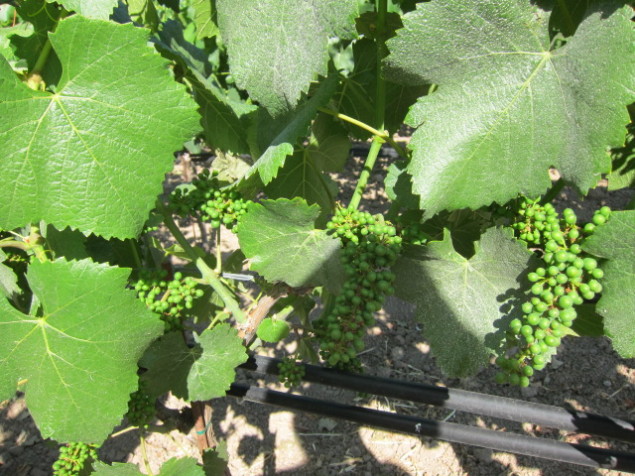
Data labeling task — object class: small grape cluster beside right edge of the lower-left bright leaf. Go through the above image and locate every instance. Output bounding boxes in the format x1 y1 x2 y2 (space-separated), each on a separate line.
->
134 269 205 331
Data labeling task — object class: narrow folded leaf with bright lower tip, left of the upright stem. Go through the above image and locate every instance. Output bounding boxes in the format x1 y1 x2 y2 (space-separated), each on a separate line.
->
247 75 336 185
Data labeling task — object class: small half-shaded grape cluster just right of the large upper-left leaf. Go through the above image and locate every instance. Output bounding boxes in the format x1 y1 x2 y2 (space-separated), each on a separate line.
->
170 170 248 230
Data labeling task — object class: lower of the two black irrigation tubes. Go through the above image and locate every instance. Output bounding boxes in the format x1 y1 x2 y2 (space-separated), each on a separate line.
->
227 383 635 472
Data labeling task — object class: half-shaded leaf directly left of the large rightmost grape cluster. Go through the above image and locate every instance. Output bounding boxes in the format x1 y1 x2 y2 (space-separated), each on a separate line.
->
393 228 532 377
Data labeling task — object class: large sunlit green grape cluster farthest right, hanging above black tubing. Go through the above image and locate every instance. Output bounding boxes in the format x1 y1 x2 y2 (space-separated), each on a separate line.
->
496 200 611 387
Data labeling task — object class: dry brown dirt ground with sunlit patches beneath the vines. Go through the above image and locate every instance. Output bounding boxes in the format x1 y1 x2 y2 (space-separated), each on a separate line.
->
0 147 635 476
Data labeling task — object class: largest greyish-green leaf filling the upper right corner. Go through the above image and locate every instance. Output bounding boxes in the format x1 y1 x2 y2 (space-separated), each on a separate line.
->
387 0 635 215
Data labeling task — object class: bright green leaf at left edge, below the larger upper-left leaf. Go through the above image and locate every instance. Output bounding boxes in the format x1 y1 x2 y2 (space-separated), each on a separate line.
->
0 260 163 443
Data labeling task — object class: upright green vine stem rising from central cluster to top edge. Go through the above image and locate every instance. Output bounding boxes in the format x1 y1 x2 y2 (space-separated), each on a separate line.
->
348 0 388 210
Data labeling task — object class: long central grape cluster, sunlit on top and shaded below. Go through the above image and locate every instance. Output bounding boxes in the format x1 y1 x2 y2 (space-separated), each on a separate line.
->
314 208 401 370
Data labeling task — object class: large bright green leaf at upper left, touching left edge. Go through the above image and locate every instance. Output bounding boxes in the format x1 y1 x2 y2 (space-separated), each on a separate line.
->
0 15 199 238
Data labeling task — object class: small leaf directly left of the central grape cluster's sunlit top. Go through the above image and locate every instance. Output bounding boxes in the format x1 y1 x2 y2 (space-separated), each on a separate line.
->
237 198 342 290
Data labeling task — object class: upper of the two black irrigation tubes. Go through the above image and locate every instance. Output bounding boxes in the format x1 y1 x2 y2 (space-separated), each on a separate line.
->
241 356 635 442
